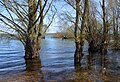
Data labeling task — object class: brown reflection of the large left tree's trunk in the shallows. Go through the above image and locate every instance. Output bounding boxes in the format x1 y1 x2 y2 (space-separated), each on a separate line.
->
25 59 44 82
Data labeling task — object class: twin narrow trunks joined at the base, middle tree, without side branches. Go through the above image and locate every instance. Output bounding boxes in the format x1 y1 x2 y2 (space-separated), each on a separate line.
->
74 0 88 65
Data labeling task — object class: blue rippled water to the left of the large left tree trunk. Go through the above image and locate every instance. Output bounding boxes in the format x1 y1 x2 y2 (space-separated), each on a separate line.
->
0 40 26 75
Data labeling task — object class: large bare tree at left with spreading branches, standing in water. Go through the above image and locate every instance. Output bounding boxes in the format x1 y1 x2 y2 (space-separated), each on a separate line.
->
0 0 56 59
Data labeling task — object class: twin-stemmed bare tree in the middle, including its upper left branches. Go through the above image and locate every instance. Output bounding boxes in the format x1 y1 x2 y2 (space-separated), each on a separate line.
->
65 0 89 65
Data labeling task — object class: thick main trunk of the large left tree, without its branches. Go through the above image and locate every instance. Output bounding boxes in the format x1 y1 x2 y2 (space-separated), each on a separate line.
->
25 0 41 59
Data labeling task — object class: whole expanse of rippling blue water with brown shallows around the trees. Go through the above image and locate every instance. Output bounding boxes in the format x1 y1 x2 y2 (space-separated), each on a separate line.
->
0 38 120 82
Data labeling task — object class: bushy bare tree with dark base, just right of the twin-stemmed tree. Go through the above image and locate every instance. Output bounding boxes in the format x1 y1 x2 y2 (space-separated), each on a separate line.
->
85 1 102 52
